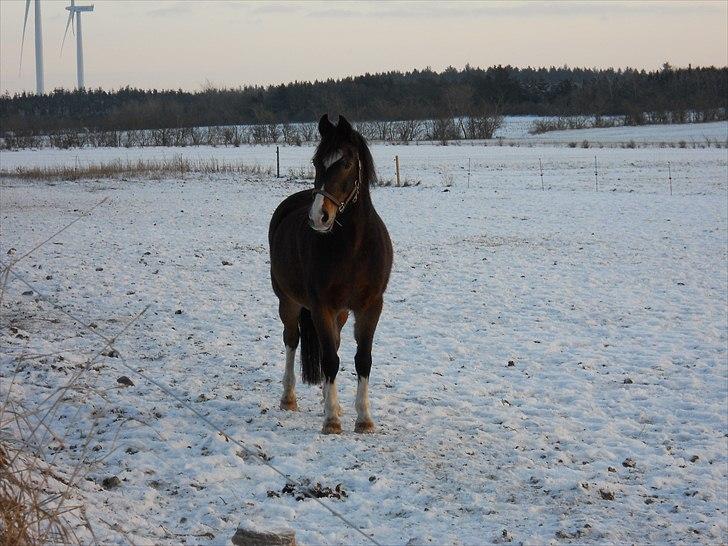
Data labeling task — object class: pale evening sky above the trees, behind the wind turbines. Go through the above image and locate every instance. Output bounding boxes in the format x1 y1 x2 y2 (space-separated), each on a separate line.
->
0 0 728 93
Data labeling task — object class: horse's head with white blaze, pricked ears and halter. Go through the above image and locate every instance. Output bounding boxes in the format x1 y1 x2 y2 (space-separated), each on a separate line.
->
308 114 374 233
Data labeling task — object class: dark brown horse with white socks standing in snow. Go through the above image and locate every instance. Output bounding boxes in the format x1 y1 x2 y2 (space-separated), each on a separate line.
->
268 114 393 434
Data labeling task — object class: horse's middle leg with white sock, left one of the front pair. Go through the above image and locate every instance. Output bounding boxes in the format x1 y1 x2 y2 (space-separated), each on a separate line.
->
311 308 341 434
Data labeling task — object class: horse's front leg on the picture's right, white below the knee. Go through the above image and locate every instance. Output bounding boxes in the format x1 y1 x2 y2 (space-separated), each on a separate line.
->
354 298 382 432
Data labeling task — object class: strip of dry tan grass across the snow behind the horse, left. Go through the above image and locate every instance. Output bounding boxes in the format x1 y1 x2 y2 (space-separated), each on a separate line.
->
0 156 273 180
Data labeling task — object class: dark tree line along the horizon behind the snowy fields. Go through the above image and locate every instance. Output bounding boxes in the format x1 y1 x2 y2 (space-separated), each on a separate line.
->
0 64 728 135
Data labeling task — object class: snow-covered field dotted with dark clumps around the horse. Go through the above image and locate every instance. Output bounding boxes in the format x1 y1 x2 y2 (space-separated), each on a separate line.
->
0 128 728 545
